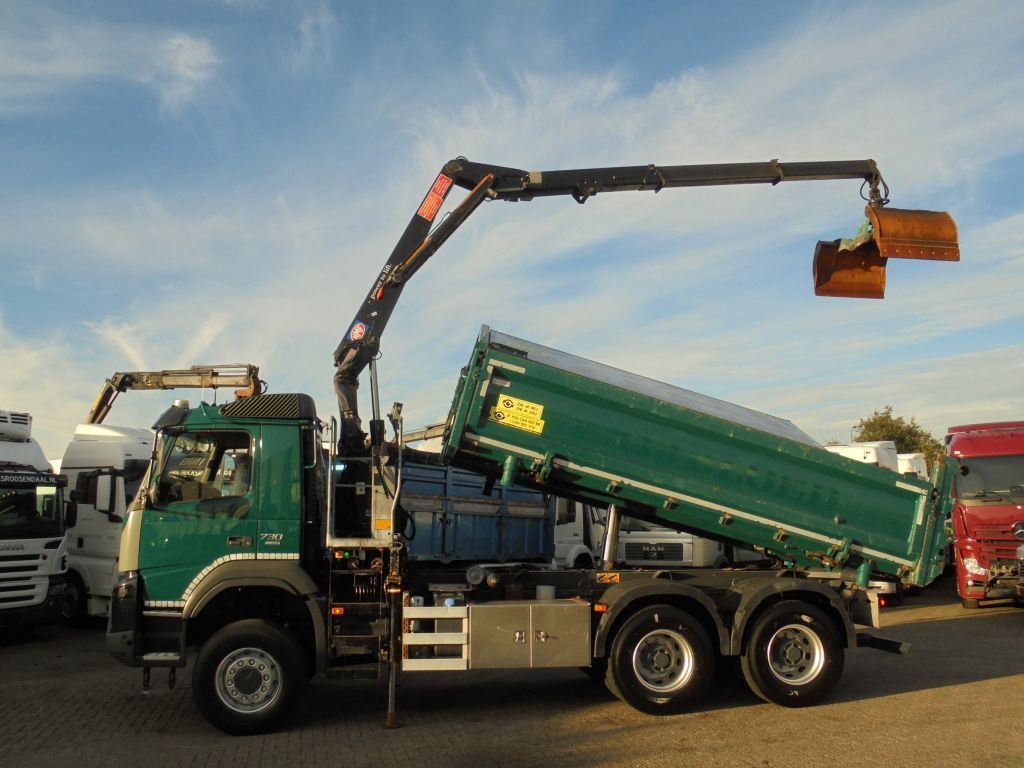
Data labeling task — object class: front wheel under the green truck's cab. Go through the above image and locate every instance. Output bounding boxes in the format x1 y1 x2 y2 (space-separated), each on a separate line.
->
193 618 307 735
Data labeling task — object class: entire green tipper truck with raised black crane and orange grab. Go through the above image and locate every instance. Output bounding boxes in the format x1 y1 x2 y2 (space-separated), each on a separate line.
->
108 158 958 733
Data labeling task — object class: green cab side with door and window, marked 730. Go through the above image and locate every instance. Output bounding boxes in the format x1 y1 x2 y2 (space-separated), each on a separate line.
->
138 403 302 607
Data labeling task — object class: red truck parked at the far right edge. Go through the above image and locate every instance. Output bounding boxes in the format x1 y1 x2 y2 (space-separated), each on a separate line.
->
946 421 1024 608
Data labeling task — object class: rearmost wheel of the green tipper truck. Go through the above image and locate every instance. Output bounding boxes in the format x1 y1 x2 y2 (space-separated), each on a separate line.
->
740 600 844 707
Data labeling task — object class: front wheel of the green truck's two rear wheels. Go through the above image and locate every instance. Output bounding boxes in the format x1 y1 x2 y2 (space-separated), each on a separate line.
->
605 605 715 715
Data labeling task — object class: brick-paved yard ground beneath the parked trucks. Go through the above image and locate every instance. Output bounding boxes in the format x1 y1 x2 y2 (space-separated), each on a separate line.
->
0 579 1024 768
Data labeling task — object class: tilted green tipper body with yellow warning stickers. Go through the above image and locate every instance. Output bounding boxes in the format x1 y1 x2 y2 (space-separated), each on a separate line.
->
442 327 949 585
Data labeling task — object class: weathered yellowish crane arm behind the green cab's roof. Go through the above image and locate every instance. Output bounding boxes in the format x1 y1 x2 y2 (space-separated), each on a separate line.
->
85 362 265 424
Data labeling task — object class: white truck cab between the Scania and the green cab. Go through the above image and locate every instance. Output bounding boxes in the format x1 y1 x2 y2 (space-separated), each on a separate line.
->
60 424 153 623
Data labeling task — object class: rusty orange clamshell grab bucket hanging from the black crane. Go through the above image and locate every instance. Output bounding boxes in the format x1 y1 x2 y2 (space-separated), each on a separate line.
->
814 206 959 299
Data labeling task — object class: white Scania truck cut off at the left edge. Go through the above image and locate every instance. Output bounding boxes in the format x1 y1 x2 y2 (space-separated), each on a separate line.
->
0 411 74 630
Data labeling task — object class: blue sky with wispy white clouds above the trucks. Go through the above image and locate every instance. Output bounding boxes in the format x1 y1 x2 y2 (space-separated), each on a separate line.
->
0 0 1024 457
